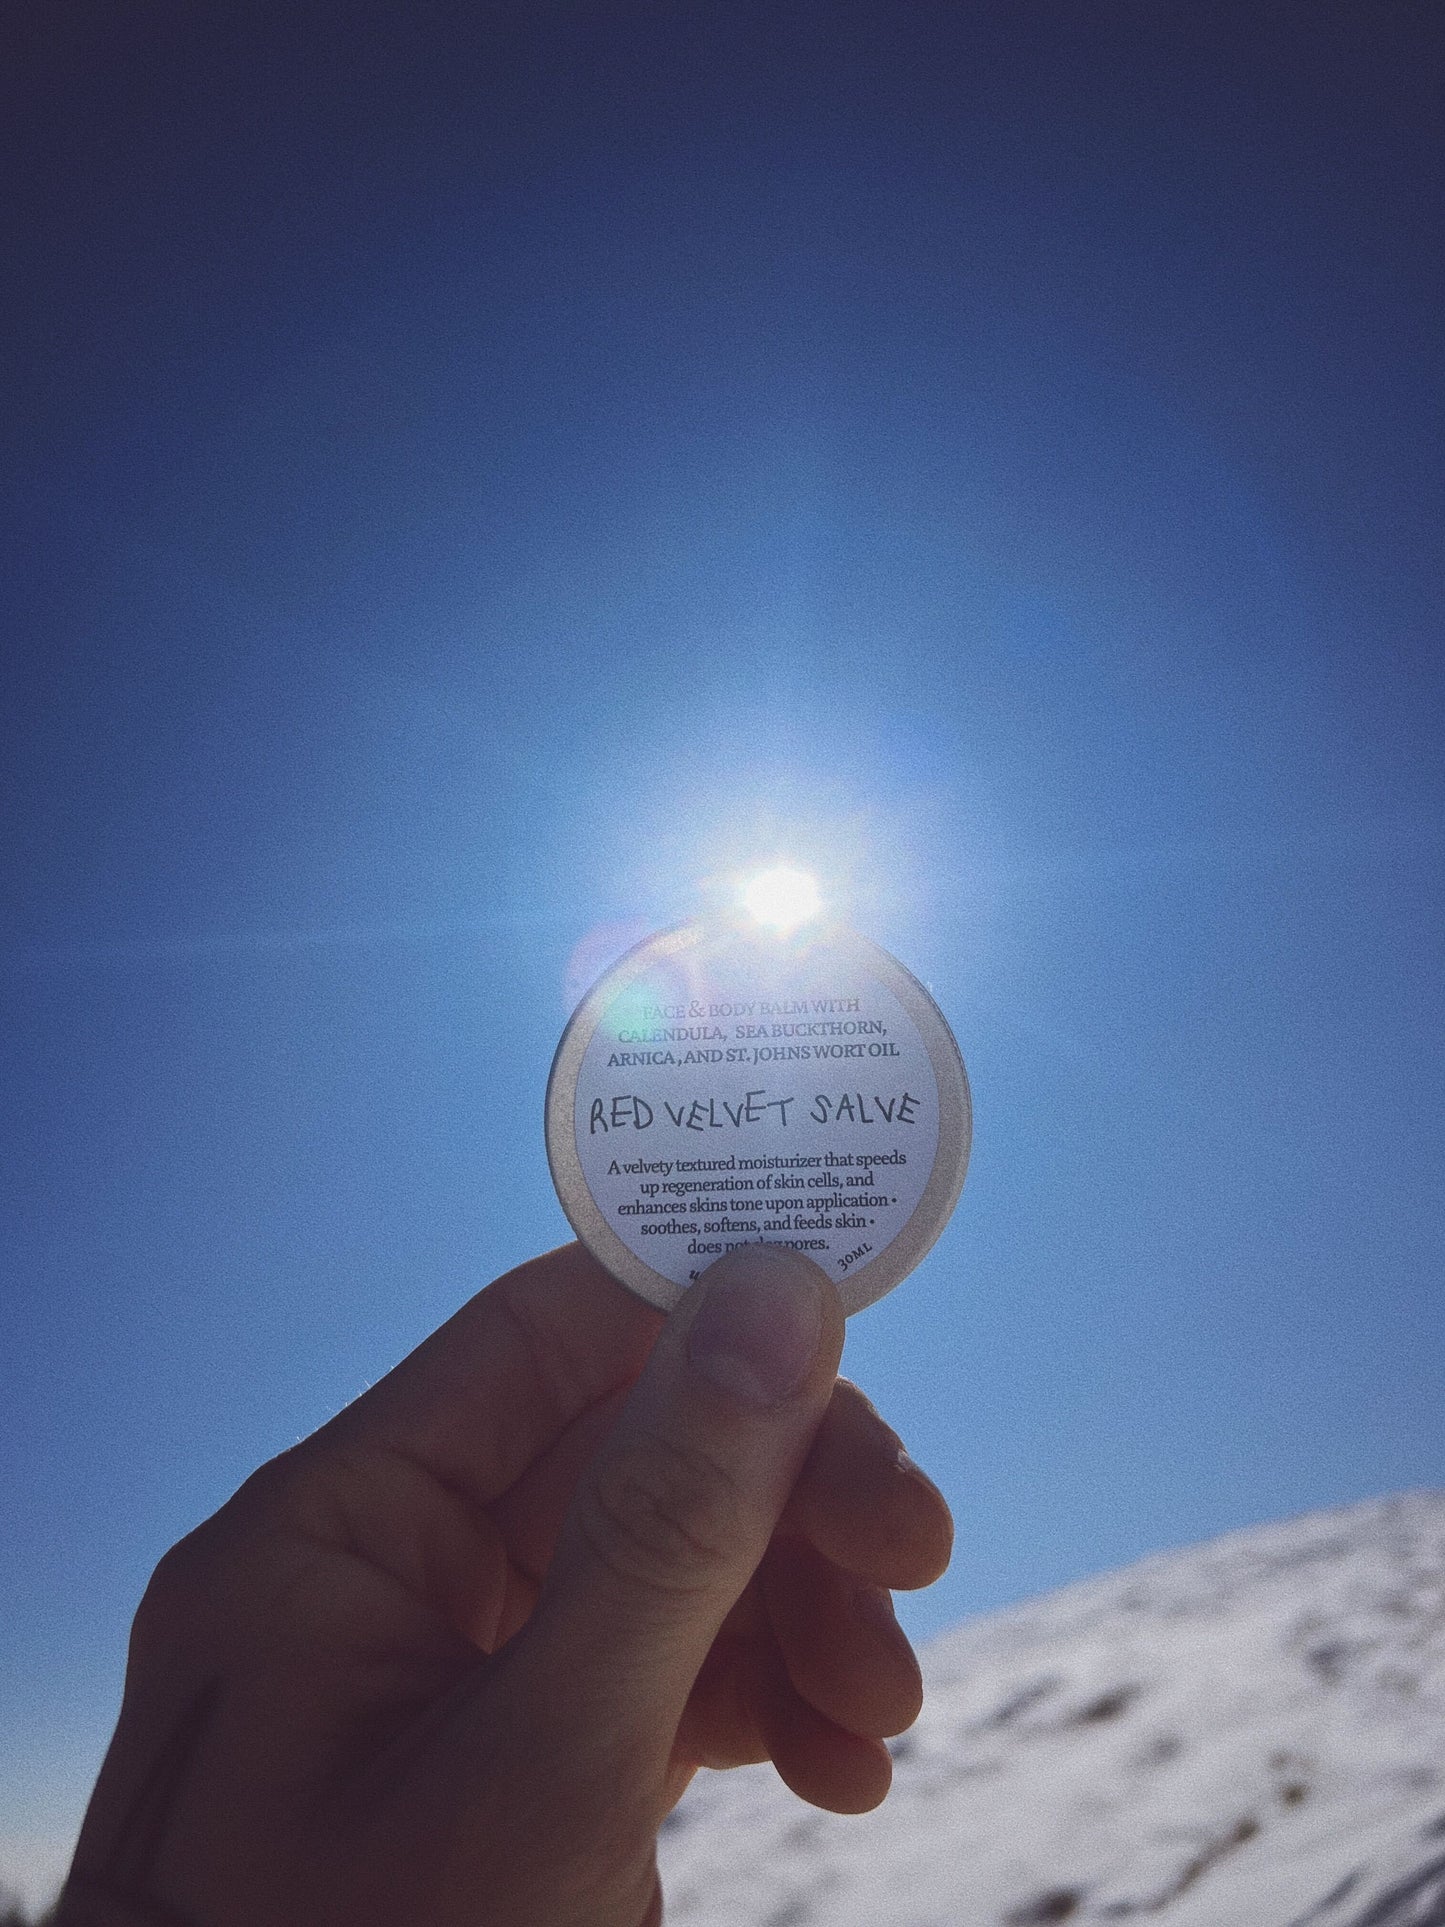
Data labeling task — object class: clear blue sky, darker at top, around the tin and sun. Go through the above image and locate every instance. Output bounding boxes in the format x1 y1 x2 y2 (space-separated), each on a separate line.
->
0 0 1445 1885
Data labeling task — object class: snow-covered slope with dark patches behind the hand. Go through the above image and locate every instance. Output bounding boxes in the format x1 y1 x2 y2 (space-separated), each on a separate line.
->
661 1493 1445 1927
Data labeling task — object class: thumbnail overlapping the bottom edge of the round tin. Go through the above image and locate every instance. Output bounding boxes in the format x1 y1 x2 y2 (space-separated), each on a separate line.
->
688 1245 823 1405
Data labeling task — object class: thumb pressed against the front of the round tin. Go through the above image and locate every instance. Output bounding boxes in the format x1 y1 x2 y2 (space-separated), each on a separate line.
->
497 1245 844 1767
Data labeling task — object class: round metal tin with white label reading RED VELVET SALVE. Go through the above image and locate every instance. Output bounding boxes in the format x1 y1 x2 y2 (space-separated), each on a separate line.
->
547 925 969 1310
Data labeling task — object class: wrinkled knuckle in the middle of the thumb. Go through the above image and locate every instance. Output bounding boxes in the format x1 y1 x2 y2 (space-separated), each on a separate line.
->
582 1434 742 1594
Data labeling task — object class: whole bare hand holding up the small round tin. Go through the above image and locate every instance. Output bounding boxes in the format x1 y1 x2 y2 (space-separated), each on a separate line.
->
58 1245 952 1927
